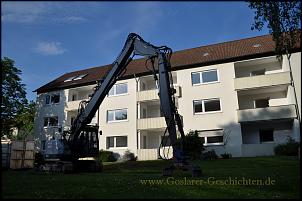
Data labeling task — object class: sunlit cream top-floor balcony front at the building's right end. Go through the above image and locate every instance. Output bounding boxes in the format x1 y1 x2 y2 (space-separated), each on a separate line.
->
234 72 290 91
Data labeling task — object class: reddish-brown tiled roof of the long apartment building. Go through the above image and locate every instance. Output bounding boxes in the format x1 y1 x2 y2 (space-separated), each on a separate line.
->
35 32 300 93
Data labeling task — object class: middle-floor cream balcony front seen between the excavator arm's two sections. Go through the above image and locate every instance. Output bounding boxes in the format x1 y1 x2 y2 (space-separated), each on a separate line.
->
137 117 167 130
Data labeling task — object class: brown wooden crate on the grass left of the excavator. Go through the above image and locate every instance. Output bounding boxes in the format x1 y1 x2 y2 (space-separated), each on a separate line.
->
10 140 35 169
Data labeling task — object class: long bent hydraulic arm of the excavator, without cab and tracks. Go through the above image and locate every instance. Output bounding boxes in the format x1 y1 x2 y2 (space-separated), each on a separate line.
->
68 33 202 175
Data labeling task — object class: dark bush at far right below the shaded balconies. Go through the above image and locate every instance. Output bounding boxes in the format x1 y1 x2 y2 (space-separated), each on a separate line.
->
274 137 300 156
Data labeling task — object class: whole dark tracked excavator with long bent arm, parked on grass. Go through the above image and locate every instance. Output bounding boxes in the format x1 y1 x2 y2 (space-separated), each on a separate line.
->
39 33 202 177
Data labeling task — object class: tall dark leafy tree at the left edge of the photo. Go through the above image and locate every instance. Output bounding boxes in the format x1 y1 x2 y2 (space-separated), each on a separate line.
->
1 57 28 137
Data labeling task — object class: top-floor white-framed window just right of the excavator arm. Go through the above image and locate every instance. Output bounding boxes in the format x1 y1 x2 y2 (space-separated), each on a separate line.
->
192 70 218 85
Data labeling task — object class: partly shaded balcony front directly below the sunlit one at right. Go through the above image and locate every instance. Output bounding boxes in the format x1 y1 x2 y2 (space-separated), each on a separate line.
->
237 105 297 123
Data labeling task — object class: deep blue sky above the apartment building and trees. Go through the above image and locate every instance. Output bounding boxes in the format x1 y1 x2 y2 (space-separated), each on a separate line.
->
1 1 268 100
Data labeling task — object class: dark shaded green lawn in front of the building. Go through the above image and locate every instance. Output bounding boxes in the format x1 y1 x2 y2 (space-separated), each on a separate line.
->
2 157 300 198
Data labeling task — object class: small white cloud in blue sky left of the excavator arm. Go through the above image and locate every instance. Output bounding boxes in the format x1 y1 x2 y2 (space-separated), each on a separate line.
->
34 42 66 55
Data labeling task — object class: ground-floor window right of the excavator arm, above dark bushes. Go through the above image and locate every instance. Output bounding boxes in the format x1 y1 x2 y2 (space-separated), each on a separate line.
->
198 129 223 146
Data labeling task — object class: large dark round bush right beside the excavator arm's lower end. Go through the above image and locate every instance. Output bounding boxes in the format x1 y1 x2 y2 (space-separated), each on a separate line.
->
176 131 204 160
